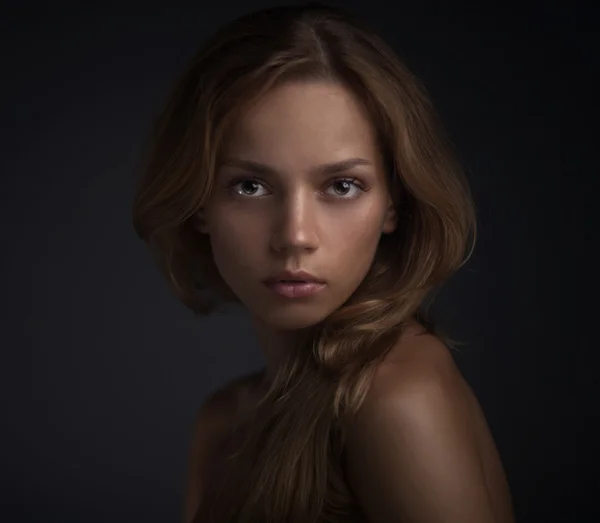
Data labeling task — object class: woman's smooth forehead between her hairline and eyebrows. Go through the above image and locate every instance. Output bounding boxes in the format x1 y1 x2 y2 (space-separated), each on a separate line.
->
226 82 377 166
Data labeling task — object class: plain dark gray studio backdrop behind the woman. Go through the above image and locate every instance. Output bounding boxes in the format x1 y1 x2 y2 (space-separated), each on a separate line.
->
0 1 600 523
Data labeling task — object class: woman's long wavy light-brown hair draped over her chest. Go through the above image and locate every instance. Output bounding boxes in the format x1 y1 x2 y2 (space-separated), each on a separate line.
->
133 3 476 523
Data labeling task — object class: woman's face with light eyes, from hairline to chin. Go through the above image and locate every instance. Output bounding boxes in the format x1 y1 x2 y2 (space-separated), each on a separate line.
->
197 83 396 330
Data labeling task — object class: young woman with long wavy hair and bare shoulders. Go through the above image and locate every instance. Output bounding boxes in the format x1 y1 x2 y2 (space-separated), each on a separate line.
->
134 4 513 523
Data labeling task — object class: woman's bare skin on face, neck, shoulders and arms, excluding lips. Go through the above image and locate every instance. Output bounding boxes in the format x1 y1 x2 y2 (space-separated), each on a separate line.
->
185 78 514 523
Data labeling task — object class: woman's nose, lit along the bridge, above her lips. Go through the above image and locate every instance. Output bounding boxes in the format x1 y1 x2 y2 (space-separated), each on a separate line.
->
271 193 319 254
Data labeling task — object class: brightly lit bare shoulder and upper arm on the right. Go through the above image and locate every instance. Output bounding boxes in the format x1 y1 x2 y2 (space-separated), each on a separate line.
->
346 333 514 523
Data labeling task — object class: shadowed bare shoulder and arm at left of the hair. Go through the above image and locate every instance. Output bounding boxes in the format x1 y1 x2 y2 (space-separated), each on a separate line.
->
184 373 260 523
